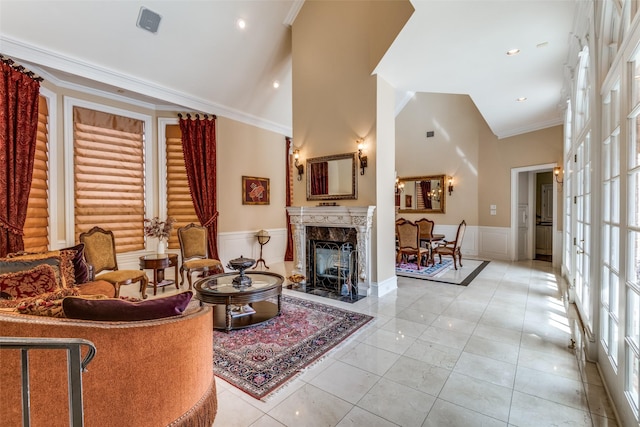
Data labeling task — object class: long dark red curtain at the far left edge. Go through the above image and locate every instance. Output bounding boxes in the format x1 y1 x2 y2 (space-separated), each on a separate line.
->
0 62 40 257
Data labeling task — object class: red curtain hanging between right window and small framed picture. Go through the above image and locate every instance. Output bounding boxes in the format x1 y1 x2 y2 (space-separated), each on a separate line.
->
179 114 220 259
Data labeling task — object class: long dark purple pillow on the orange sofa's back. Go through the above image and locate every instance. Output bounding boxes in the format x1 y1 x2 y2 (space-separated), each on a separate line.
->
62 291 193 321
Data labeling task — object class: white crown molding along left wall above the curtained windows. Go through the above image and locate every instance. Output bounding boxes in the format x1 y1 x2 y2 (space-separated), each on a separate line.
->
0 35 292 135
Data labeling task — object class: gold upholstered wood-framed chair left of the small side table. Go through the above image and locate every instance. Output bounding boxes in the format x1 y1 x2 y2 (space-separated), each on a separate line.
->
79 226 149 299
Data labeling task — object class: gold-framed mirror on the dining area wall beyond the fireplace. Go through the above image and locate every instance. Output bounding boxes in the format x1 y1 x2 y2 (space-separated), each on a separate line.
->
396 175 447 213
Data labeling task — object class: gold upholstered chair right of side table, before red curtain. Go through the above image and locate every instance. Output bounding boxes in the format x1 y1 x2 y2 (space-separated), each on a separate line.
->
178 223 224 289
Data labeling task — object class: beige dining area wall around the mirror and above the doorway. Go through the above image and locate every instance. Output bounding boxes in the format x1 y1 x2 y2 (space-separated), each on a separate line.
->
396 93 563 231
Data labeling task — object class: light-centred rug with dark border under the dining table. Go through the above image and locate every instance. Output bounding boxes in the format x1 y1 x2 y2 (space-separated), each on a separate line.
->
396 257 489 286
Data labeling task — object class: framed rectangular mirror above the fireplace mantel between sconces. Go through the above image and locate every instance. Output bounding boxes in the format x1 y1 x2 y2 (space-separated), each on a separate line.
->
307 153 358 200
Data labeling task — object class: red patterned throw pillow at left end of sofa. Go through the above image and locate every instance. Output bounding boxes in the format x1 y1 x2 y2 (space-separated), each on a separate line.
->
0 264 60 300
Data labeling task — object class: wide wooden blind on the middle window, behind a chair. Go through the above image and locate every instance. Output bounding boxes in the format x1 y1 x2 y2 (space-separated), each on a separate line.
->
73 107 145 253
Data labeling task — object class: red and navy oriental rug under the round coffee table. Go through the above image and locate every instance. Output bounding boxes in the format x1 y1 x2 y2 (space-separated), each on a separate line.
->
213 295 373 399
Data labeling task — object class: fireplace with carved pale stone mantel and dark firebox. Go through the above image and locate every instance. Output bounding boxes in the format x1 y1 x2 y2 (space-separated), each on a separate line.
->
287 206 375 296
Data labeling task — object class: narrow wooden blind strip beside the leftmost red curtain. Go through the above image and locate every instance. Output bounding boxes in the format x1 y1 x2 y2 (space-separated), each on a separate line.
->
24 96 49 252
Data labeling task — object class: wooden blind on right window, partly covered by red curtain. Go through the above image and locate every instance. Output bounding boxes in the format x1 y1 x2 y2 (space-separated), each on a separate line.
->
165 125 200 249
